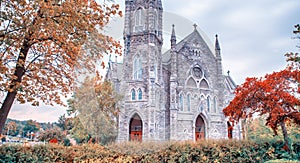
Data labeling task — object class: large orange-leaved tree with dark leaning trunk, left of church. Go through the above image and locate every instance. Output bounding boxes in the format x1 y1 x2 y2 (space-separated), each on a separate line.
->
0 0 121 132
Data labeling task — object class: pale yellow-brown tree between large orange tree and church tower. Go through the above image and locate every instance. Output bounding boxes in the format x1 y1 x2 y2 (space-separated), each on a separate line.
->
69 76 121 143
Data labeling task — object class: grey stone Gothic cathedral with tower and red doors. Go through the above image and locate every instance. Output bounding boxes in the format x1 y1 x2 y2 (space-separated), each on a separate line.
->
106 0 241 142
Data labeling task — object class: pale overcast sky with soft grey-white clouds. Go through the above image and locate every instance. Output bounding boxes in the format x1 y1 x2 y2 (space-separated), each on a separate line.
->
9 0 300 122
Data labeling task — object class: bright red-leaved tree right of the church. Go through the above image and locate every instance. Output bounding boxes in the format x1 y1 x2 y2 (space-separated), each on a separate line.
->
223 62 300 148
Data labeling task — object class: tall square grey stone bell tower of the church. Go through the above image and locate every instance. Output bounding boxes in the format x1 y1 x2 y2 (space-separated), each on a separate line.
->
118 0 165 141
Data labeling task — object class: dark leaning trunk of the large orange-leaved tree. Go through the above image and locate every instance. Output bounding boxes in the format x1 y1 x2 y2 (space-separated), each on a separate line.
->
0 38 30 133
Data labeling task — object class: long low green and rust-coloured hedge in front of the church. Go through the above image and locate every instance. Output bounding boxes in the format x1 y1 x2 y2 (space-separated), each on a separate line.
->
0 140 300 163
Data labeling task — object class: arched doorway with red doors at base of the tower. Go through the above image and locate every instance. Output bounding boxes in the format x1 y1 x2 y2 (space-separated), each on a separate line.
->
129 114 143 141
